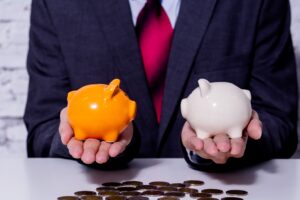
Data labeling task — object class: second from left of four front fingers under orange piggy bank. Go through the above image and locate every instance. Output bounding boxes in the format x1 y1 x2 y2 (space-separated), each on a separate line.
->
81 139 100 164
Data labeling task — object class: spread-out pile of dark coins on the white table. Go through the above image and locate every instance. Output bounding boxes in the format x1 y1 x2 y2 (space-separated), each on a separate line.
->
57 180 248 200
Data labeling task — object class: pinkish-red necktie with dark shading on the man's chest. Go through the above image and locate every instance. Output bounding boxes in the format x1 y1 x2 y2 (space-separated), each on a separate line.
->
136 0 173 122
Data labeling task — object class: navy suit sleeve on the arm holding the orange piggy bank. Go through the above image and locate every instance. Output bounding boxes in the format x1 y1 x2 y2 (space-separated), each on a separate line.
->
24 0 138 165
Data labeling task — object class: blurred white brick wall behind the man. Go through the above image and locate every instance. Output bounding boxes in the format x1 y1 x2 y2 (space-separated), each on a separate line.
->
0 0 300 158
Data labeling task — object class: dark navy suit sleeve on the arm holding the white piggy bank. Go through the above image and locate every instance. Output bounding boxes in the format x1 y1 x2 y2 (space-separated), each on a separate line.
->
186 0 298 170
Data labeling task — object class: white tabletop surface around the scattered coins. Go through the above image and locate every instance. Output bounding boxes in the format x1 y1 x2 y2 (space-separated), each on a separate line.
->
0 159 300 200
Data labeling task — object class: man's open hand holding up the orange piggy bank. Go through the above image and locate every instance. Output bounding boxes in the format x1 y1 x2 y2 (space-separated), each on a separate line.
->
59 108 133 164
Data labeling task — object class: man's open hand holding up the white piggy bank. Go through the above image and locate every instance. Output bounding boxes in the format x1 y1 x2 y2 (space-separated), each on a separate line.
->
181 111 262 164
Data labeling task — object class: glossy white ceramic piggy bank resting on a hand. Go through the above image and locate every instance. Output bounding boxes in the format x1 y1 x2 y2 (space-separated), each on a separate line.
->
181 79 252 139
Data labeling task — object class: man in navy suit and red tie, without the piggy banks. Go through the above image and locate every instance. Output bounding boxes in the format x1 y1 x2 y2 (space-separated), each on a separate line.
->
24 0 298 170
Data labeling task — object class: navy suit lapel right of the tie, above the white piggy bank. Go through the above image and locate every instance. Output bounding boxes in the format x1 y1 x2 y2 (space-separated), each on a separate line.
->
158 0 217 147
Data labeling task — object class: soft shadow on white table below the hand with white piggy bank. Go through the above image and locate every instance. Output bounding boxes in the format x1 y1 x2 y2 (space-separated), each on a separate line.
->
203 161 278 185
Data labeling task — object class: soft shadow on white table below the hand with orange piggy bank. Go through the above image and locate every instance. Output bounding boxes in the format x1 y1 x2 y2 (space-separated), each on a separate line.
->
83 159 161 185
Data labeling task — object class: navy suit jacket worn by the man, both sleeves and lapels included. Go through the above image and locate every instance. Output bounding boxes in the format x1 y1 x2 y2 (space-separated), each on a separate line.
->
24 0 298 168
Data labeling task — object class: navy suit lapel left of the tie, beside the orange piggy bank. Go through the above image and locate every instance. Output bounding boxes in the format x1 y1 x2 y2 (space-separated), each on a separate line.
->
91 0 158 155
